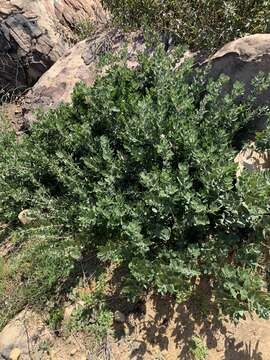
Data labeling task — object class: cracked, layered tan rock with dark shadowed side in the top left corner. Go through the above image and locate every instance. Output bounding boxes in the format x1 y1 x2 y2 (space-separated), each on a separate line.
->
0 0 106 96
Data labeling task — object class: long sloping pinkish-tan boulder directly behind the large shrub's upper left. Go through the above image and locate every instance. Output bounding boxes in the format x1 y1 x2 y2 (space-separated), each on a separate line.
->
23 30 147 122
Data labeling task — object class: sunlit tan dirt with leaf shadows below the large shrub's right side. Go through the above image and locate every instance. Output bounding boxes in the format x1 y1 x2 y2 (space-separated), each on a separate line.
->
112 297 270 360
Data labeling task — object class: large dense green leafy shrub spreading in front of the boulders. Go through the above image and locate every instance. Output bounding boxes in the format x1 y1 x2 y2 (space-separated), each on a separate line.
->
0 46 270 322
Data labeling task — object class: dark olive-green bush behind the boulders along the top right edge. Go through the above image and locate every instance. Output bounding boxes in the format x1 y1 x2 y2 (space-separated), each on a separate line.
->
103 0 270 50
